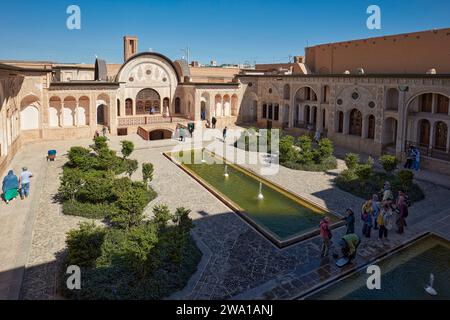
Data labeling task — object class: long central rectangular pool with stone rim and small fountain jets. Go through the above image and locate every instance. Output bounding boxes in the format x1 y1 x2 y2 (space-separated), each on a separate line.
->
165 150 342 247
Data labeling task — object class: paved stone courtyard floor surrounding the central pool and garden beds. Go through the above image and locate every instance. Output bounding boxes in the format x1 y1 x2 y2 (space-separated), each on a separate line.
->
0 131 450 299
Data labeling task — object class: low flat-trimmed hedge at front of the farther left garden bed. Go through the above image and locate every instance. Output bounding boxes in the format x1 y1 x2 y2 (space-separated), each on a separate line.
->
62 201 117 219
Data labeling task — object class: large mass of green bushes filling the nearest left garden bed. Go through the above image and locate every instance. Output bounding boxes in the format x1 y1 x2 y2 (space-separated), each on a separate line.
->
61 205 201 300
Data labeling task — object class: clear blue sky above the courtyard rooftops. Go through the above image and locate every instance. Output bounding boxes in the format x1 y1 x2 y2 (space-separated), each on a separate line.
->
0 0 450 63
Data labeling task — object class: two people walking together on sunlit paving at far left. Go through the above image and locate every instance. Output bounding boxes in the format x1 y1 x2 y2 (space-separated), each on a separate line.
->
2 167 33 204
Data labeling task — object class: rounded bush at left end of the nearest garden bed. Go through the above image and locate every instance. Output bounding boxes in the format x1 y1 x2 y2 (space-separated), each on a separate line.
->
66 223 105 267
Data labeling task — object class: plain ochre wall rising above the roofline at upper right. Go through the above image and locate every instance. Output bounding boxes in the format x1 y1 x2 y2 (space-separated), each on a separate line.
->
305 28 450 74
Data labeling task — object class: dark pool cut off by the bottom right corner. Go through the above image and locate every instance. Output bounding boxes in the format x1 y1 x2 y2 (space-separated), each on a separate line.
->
306 235 450 300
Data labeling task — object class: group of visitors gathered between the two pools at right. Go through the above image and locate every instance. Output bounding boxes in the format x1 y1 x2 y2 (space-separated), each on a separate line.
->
320 181 410 262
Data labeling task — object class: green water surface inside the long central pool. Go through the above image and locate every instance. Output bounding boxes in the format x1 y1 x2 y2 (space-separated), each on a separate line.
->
167 150 337 241
